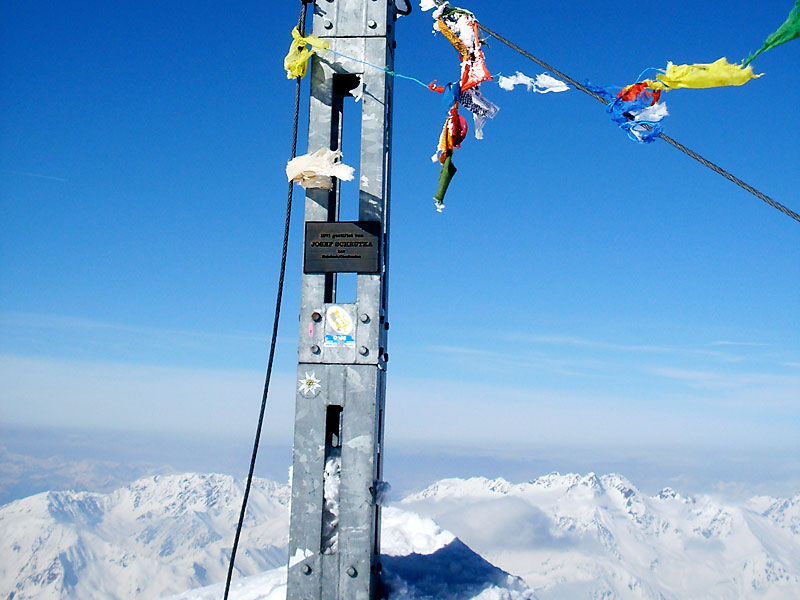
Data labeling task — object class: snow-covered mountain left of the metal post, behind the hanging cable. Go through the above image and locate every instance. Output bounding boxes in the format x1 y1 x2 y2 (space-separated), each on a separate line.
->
0 474 290 600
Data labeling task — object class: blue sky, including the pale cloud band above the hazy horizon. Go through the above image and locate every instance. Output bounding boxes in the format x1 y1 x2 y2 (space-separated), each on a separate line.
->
0 0 800 478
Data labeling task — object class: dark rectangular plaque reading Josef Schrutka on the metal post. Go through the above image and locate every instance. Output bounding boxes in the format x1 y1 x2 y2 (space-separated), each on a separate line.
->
303 221 381 273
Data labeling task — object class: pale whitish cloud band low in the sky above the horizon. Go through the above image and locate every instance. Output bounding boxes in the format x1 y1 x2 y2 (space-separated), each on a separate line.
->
0 354 800 446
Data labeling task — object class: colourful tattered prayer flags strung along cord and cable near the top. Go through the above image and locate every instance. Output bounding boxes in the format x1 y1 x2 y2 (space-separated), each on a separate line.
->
284 0 800 220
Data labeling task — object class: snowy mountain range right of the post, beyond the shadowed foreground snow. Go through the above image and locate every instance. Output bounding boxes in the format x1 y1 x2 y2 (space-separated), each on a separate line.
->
401 473 800 600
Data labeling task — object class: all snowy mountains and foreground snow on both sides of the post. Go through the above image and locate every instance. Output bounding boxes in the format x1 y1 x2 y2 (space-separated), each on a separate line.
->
0 473 800 600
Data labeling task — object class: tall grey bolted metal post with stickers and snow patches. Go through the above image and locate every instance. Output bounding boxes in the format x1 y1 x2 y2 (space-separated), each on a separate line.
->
287 0 396 600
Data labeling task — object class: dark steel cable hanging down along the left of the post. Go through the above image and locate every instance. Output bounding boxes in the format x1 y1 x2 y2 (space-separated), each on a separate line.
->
224 0 308 600
